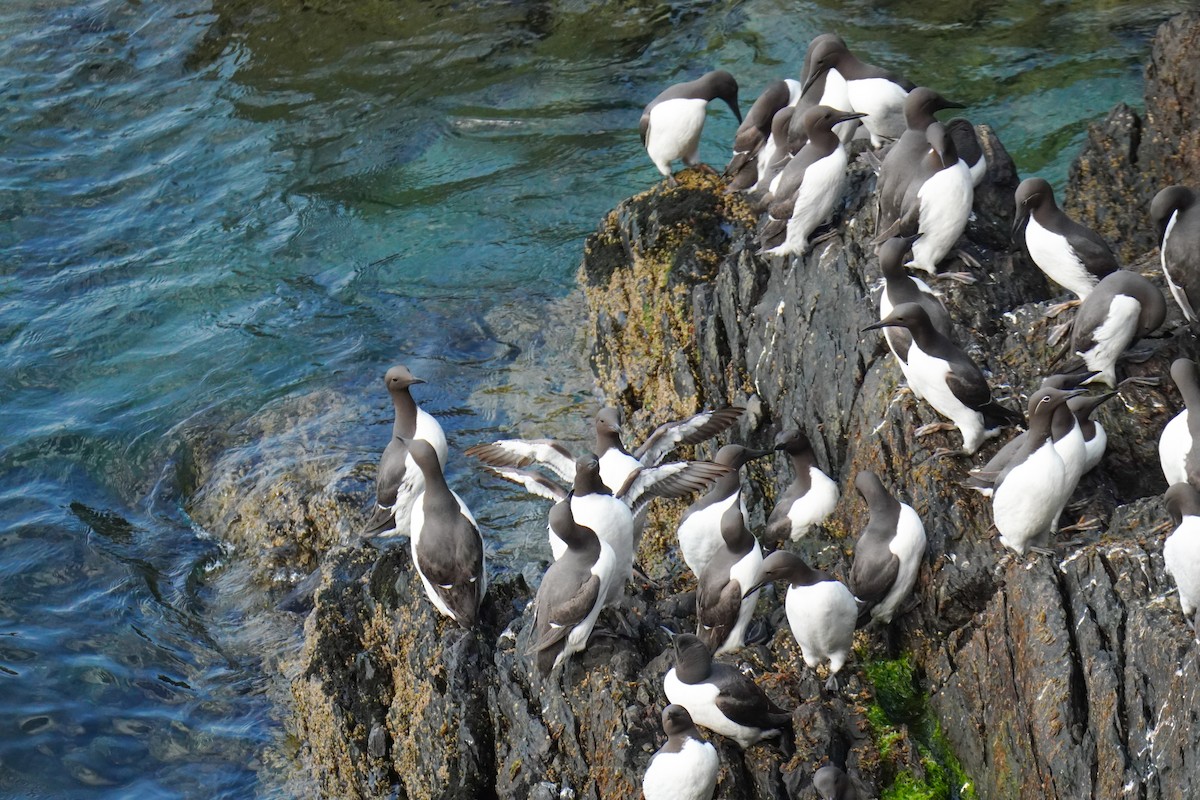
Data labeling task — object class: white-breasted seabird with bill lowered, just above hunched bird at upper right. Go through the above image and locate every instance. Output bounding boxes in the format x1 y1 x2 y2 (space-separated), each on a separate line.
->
1013 178 1121 309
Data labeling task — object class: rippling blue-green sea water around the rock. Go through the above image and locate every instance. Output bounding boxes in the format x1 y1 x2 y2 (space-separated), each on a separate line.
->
0 0 1186 798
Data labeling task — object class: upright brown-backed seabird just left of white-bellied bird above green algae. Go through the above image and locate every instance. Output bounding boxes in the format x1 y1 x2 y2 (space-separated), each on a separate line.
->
696 505 762 655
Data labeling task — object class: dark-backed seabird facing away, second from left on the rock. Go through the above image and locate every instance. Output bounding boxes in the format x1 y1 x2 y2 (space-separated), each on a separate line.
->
408 439 487 627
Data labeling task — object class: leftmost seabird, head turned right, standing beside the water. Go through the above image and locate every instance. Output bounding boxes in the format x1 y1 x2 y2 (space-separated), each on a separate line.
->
365 366 446 537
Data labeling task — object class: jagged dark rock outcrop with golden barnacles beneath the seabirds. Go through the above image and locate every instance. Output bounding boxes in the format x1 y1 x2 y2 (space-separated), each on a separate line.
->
180 7 1200 799
